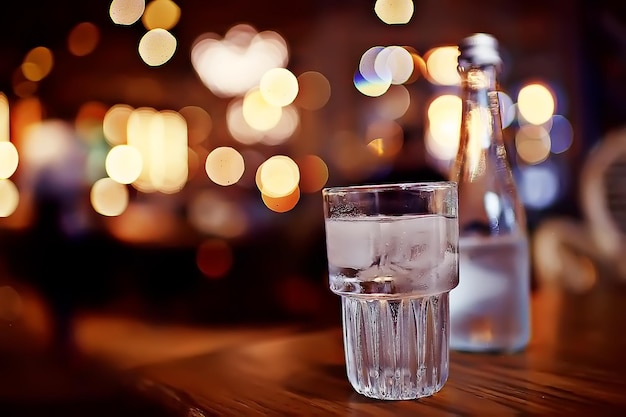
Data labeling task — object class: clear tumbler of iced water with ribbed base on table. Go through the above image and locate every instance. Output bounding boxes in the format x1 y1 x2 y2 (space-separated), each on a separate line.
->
322 181 459 400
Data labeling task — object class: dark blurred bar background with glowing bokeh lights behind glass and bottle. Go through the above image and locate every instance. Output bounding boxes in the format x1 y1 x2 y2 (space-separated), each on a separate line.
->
0 0 626 352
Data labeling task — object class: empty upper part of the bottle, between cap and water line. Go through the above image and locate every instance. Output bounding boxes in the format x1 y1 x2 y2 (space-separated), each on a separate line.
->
450 65 526 236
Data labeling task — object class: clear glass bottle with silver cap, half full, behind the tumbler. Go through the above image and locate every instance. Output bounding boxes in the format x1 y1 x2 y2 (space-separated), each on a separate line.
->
450 33 530 352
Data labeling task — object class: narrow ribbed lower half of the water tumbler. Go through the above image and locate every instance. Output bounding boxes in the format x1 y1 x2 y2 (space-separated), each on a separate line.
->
342 292 450 400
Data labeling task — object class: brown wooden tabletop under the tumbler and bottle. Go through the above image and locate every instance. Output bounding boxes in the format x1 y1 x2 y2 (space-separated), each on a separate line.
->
133 285 626 417
